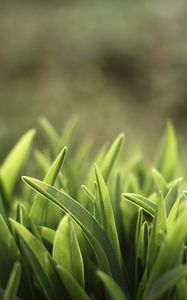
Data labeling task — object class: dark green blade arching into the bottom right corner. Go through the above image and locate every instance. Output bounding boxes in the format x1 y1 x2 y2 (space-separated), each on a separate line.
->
146 266 187 300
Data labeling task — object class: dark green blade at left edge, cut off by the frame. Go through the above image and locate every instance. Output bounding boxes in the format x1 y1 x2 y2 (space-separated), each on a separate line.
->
0 215 20 288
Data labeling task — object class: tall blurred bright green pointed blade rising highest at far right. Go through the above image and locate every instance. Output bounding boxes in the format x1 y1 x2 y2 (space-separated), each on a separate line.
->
156 122 178 182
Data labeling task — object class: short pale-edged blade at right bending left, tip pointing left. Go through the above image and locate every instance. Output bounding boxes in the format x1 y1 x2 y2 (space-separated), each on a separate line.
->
122 193 156 217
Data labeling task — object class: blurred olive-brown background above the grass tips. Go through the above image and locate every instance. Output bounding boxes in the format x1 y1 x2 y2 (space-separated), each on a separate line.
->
0 0 187 158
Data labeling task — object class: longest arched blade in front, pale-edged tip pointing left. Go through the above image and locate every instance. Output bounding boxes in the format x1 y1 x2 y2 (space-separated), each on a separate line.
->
23 177 125 289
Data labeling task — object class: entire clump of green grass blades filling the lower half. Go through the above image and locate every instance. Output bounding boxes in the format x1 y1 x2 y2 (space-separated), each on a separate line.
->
0 118 187 300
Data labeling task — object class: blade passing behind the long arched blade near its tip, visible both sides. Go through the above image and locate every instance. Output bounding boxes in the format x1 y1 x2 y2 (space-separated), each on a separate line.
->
30 147 67 228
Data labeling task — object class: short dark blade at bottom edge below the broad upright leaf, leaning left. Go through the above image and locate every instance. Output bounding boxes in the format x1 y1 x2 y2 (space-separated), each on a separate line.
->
57 266 91 300
